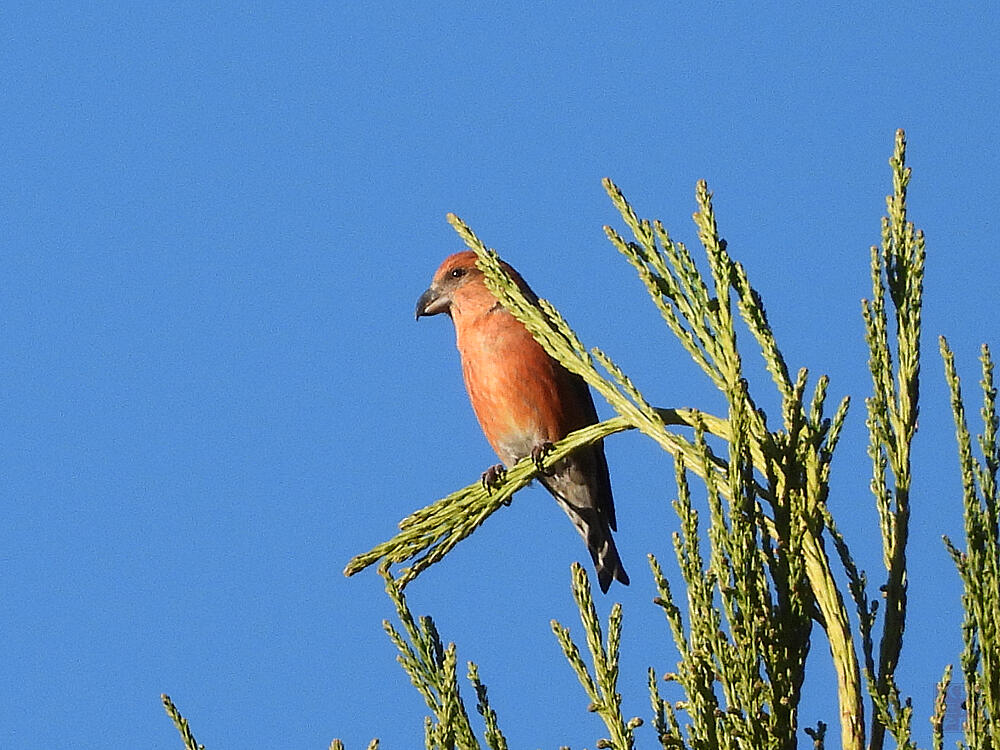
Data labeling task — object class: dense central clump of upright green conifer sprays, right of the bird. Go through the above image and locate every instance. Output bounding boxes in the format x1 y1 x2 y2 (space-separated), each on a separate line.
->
605 172 860 748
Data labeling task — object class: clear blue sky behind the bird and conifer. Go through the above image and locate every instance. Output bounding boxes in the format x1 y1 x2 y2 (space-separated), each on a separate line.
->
0 2 1000 749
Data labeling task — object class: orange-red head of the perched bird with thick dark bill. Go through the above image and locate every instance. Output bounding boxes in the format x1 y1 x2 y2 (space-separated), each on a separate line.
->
416 250 534 320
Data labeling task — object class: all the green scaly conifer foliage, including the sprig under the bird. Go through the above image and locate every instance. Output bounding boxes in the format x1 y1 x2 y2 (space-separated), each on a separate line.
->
164 131 1000 750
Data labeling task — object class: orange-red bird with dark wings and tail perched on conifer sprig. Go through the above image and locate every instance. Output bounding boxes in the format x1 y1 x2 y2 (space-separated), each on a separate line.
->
416 251 628 592
